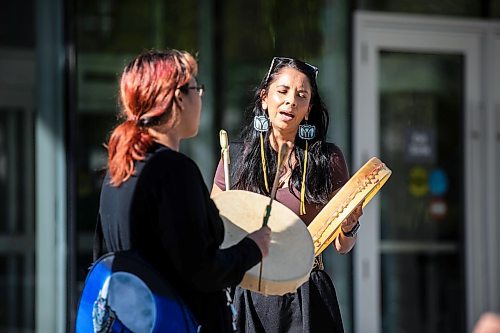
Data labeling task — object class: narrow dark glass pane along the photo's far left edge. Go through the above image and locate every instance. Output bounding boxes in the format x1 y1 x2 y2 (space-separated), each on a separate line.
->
0 1 35 332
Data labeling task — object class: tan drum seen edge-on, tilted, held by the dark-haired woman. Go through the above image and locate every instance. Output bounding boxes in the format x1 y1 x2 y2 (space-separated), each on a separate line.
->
307 157 392 255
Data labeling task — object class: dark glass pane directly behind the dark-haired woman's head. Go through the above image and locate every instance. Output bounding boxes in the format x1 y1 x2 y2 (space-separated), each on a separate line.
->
216 0 325 138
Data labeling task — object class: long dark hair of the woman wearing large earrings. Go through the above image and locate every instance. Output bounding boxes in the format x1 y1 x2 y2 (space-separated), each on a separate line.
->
232 58 334 204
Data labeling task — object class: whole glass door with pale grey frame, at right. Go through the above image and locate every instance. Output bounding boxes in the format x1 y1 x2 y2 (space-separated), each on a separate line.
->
353 13 498 333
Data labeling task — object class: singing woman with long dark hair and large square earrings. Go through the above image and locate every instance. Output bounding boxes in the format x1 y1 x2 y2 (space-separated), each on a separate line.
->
212 57 362 333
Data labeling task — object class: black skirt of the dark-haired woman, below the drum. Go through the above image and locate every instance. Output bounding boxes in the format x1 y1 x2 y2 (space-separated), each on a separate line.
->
234 270 344 333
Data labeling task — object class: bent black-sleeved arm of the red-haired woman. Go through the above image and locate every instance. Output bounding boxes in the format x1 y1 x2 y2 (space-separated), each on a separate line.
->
159 159 262 291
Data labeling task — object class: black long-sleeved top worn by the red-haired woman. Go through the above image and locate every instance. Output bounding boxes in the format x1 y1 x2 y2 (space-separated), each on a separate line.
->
99 144 261 332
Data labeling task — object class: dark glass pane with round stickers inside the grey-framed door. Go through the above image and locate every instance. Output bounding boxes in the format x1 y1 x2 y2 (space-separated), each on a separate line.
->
378 49 465 333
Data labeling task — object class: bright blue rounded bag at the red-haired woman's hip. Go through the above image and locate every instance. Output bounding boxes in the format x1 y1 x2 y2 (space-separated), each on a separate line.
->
76 251 201 333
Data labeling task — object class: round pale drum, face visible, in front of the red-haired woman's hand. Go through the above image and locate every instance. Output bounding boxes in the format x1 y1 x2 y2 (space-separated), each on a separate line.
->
213 190 314 295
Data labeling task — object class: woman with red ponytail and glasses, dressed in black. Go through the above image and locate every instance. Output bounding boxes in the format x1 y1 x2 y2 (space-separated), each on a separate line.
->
95 50 270 332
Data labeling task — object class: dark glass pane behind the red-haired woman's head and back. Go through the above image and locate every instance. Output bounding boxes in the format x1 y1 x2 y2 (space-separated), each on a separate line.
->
74 0 199 287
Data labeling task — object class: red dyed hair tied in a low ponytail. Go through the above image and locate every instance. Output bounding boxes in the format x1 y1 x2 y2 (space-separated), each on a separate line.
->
108 49 198 186
